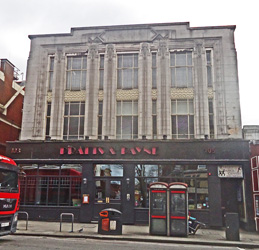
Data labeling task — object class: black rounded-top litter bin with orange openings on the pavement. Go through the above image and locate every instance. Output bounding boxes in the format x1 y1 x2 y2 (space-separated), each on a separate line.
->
98 208 122 235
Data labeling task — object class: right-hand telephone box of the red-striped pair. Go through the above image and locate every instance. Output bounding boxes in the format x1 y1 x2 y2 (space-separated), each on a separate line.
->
168 182 189 236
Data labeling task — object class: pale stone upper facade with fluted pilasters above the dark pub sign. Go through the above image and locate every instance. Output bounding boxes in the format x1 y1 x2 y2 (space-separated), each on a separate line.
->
21 23 242 140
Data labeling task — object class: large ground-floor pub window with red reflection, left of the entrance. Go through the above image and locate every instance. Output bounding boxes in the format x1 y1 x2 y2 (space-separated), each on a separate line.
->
20 164 82 206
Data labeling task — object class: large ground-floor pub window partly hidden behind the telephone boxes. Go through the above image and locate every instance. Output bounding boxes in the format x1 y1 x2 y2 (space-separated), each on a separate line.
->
135 164 209 210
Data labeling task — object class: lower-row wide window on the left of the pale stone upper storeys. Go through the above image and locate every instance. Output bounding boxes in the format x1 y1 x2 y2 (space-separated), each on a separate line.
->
63 102 85 140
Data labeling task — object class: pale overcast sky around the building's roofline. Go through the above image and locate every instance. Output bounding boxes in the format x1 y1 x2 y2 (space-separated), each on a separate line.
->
0 0 259 125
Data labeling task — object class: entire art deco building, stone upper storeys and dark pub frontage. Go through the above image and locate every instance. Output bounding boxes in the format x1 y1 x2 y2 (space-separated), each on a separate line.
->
9 23 255 227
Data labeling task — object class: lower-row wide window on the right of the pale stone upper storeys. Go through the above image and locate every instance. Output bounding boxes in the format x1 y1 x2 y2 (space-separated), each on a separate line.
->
171 99 194 139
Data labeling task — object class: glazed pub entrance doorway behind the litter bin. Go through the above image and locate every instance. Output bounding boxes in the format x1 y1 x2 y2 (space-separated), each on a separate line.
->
93 164 123 220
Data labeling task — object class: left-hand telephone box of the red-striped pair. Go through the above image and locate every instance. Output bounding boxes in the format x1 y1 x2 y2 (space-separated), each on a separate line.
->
149 182 168 235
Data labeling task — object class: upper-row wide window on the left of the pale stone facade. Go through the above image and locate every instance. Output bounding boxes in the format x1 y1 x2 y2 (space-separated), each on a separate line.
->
66 56 87 90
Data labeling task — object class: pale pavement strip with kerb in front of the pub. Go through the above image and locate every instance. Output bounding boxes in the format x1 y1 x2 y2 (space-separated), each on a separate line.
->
15 220 259 249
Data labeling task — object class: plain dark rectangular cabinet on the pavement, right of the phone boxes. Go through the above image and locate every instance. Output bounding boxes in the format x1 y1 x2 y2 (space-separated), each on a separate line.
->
225 213 240 241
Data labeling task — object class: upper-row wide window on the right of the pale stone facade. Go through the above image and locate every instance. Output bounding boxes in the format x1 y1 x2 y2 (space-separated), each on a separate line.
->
170 51 193 88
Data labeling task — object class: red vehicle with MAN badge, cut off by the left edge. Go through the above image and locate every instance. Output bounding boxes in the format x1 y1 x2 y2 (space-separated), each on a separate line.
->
0 155 20 236
